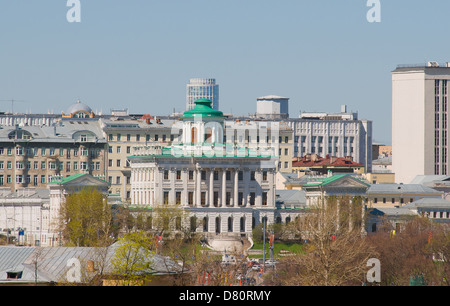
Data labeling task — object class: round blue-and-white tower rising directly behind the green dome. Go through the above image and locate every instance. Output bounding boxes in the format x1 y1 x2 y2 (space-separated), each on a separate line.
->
186 78 219 110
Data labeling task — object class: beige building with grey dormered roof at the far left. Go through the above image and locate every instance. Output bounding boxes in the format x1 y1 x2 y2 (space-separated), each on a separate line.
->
0 119 106 191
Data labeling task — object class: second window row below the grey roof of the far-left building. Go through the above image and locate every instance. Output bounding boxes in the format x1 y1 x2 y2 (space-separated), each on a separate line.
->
0 161 101 172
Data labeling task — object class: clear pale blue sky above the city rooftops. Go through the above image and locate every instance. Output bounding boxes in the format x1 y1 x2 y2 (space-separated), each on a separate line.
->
0 0 450 143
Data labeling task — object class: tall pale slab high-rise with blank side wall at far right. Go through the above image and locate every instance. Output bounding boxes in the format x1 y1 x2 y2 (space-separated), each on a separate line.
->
392 62 450 183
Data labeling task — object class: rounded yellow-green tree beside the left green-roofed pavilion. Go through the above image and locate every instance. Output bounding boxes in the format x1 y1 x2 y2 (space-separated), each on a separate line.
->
60 188 113 247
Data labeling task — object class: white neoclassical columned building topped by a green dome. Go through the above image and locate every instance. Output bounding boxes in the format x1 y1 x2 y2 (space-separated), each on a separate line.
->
129 99 278 241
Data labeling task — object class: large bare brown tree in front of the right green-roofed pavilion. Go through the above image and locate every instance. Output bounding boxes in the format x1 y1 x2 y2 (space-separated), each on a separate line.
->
279 197 376 286
